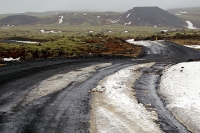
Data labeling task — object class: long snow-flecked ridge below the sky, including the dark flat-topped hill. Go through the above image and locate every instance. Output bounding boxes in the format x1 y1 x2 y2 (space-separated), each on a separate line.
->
0 7 192 28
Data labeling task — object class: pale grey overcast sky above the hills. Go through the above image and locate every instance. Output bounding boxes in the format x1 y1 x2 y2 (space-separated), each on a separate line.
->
0 0 200 14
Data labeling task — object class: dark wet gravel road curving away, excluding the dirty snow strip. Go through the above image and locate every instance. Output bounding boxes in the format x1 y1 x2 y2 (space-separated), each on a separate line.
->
0 42 200 133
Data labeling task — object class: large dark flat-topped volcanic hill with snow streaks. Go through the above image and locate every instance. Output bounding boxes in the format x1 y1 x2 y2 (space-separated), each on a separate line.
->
119 7 186 28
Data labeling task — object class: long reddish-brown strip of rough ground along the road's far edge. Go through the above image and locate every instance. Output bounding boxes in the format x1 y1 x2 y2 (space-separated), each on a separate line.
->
0 36 142 60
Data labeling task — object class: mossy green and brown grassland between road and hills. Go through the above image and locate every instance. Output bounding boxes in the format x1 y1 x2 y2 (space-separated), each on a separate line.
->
0 23 197 59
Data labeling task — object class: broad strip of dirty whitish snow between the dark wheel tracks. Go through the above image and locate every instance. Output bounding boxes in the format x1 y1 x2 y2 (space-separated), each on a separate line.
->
90 63 162 133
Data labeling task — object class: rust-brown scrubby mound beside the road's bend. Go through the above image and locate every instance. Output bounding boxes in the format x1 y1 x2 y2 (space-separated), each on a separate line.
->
85 37 142 57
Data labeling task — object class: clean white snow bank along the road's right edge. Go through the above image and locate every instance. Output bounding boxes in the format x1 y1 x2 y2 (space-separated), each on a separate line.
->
159 62 200 133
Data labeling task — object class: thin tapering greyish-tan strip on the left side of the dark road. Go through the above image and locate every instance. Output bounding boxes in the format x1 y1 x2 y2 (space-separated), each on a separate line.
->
22 63 112 106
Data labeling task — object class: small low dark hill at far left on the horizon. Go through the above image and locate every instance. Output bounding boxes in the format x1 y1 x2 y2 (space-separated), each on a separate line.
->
0 15 39 25
